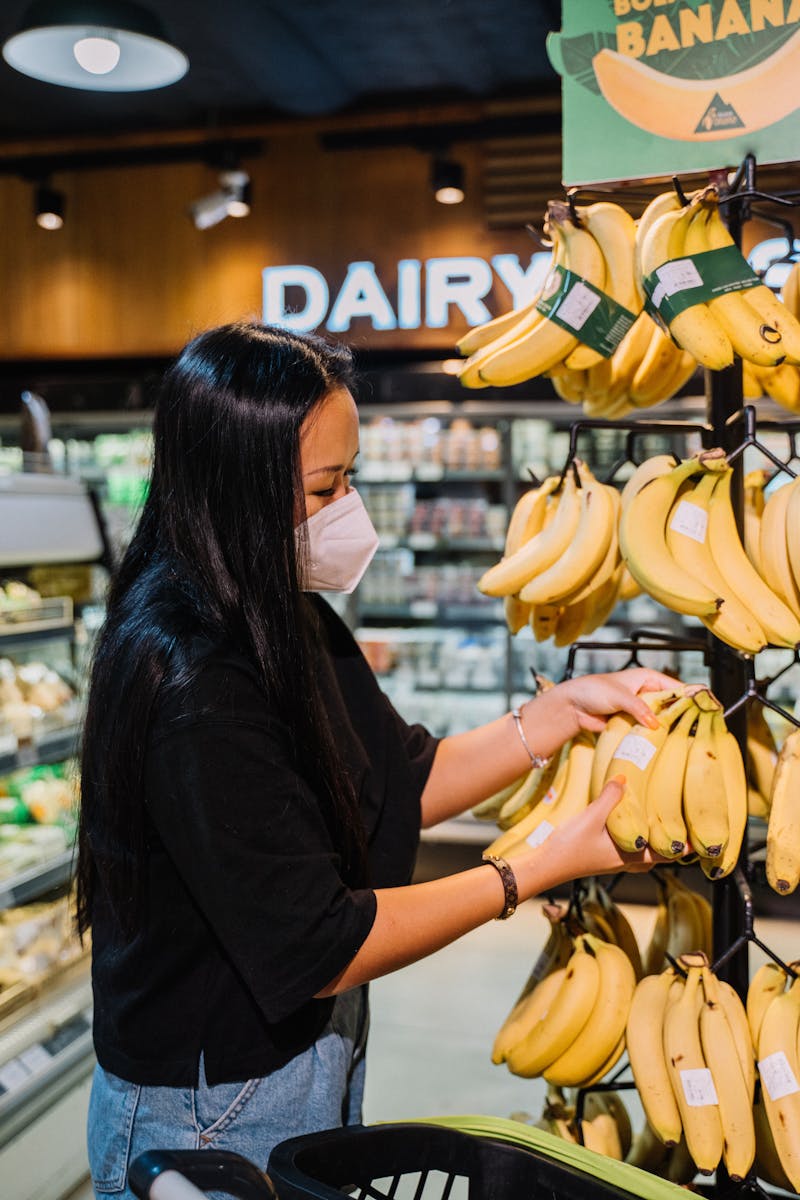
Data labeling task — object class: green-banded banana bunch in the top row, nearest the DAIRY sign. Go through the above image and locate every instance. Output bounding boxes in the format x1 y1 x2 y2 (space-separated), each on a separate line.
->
458 200 642 388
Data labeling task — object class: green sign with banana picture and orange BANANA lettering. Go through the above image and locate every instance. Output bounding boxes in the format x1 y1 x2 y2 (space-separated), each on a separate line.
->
547 0 800 185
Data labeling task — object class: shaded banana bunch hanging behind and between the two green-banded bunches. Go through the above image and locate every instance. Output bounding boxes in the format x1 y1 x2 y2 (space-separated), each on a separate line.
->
548 312 697 421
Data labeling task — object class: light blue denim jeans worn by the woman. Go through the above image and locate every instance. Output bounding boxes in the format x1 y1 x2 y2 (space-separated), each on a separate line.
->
88 986 369 1200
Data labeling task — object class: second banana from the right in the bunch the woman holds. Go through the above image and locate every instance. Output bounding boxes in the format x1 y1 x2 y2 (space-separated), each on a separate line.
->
684 713 729 858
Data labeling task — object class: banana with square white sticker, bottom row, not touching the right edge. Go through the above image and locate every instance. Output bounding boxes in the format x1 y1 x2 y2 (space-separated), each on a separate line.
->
663 966 724 1175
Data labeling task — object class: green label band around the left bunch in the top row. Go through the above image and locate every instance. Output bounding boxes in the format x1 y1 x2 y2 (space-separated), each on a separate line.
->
536 266 636 359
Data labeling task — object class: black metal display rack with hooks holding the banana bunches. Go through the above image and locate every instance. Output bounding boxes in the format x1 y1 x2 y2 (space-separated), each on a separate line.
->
534 155 800 1200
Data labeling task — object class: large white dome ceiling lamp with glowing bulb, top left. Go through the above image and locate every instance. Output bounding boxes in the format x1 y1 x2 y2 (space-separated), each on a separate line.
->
2 0 188 91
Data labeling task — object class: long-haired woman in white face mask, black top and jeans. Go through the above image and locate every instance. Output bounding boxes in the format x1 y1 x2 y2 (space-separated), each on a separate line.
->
78 324 672 1196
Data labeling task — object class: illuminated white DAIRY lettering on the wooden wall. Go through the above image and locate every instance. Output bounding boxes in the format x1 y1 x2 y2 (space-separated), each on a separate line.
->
263 252 551 334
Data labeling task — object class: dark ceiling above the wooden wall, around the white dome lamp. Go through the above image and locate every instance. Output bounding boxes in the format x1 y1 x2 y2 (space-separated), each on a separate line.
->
0 0 560 139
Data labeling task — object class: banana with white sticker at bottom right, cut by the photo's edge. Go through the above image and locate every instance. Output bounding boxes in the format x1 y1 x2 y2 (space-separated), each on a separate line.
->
758 983 800 1192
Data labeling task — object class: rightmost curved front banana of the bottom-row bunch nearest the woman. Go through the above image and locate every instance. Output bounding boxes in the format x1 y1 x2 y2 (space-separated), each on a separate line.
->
543 935 636 1087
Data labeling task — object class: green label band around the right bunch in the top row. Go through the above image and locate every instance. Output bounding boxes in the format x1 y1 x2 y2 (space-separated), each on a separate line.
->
643 246 762 325
